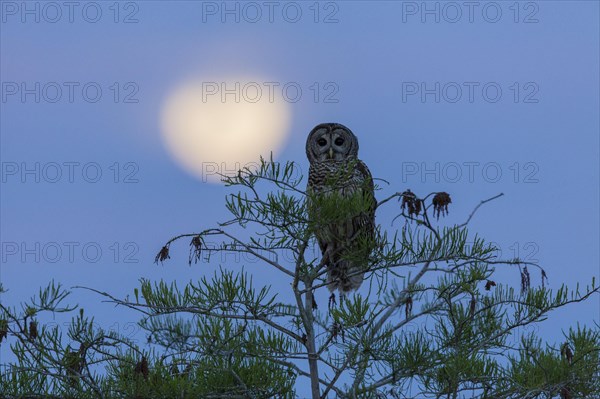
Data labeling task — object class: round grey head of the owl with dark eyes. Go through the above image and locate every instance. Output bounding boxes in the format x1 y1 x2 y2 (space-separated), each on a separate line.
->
306 123 358 163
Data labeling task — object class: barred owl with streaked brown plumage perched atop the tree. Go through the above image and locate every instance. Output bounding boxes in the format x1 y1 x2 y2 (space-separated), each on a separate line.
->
306 123 377 293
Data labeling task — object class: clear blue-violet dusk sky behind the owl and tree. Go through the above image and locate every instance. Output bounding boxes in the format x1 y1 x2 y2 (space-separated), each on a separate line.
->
0 1 600 396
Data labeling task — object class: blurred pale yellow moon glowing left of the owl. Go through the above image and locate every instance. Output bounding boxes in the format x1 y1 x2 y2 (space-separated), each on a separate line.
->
161 78 291 183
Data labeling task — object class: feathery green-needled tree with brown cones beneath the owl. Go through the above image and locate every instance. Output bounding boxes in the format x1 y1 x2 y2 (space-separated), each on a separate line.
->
0 160 600 399
